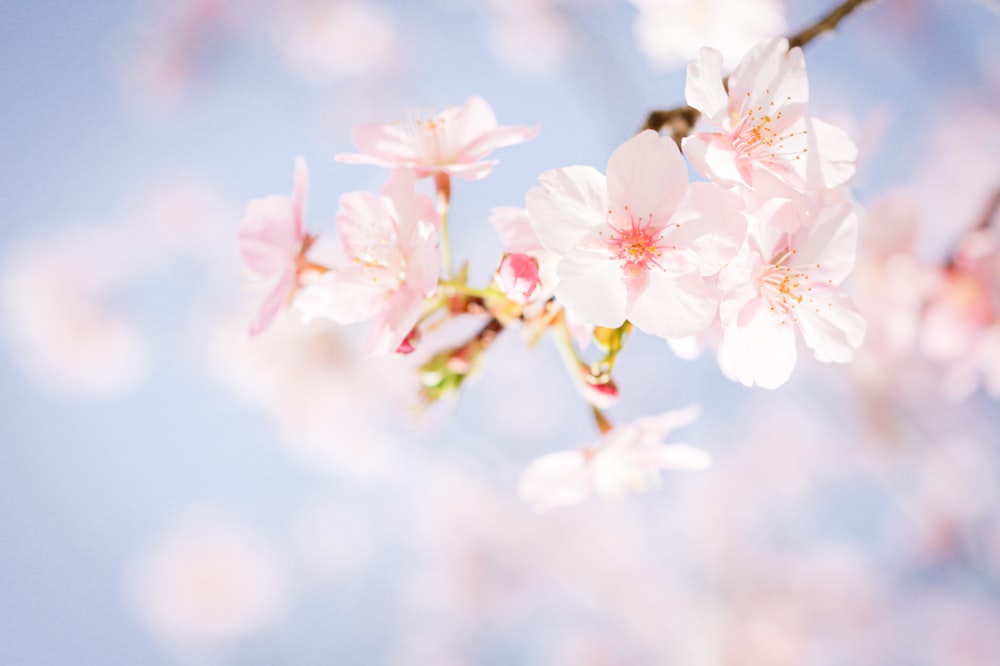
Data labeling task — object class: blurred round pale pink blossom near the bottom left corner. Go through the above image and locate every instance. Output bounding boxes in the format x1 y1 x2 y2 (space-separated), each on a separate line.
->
126 510 288 647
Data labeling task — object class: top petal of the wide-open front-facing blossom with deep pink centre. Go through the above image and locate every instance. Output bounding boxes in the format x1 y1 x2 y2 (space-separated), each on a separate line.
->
607 130 688 221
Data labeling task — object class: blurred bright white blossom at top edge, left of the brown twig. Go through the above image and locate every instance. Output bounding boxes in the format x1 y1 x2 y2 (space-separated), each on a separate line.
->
629 0 787 68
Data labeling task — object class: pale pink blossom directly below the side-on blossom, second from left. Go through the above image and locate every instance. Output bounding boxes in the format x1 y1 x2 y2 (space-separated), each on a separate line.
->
296 171 441 354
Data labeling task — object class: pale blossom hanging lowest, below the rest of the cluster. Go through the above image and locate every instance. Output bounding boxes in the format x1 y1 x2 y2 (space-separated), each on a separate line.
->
518 406 712 511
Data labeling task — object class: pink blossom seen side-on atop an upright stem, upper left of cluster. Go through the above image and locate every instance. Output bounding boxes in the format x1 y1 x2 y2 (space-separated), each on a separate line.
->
337 97 538 180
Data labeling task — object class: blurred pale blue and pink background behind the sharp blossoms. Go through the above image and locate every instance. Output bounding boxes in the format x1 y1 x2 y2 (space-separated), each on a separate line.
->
0 0 1000 666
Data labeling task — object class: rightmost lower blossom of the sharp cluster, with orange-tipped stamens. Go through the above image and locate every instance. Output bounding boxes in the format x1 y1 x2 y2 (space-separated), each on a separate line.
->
719 203 865 388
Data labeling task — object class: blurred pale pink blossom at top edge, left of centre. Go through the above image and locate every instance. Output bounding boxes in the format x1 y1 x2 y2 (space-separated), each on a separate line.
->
274 0 397 85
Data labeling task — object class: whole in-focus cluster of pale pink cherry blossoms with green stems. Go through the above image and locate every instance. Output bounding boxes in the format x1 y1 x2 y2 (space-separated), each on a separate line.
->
240 39 865 507
